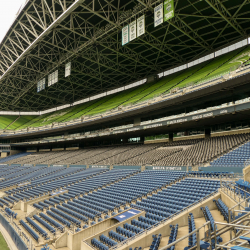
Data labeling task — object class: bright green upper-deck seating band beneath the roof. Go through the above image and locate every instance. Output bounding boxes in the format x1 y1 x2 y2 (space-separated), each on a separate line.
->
0 46 250 130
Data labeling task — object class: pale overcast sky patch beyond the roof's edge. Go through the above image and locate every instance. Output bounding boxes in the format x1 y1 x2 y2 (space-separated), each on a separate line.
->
0 0 26 42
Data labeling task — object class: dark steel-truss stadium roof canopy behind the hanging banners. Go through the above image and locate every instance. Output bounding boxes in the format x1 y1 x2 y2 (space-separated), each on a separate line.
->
0 0 250 111
